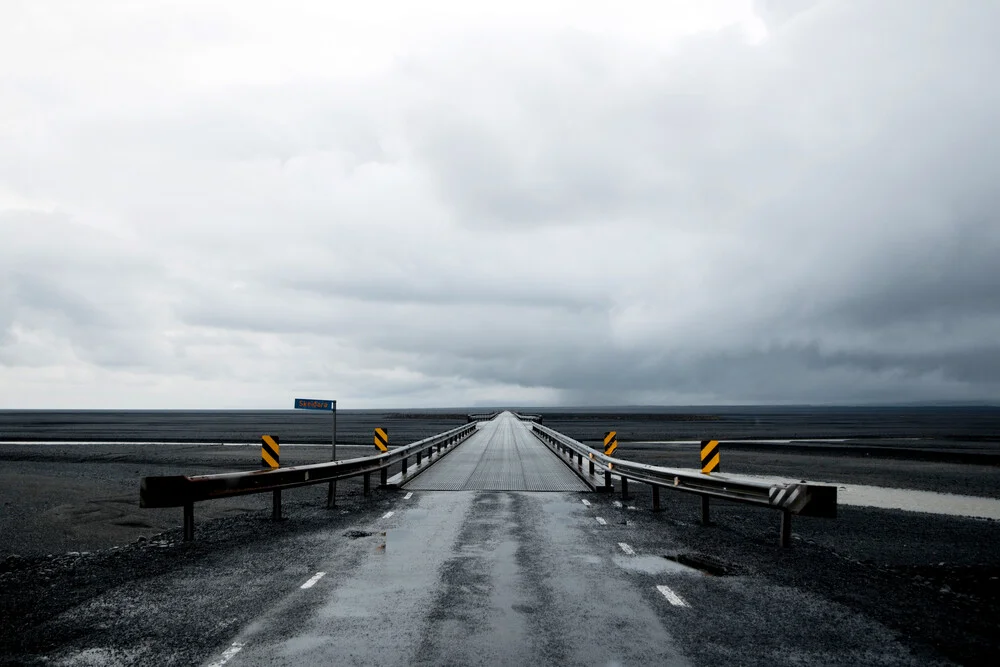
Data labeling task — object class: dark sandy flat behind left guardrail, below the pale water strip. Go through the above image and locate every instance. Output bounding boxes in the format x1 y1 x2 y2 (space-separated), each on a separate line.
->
0 444 408 558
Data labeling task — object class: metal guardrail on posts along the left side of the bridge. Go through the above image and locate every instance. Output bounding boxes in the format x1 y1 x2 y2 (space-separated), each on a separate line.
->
139 424 477 541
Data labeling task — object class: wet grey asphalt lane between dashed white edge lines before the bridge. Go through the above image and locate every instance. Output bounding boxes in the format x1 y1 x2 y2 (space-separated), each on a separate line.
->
221 491 690 665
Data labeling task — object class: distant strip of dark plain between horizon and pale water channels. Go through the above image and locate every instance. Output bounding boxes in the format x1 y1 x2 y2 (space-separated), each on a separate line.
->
0 406 1000 446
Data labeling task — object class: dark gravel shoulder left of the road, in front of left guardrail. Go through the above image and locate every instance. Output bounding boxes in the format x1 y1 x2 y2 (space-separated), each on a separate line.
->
0 488 398 665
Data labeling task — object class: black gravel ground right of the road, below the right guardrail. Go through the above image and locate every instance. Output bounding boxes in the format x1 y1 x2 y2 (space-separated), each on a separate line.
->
595 484 1000 665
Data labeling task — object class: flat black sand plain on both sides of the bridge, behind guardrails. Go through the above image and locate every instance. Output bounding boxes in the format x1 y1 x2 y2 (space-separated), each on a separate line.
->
0 408 1000 557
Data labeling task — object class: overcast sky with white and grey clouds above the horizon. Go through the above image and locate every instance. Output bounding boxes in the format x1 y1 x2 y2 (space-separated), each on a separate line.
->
0 0 1000 408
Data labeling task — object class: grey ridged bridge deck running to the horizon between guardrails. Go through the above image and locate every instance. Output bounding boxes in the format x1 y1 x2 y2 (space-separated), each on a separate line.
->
405 412 589 491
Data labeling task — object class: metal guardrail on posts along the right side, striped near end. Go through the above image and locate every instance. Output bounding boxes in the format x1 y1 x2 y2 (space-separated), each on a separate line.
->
531 424 837 547
